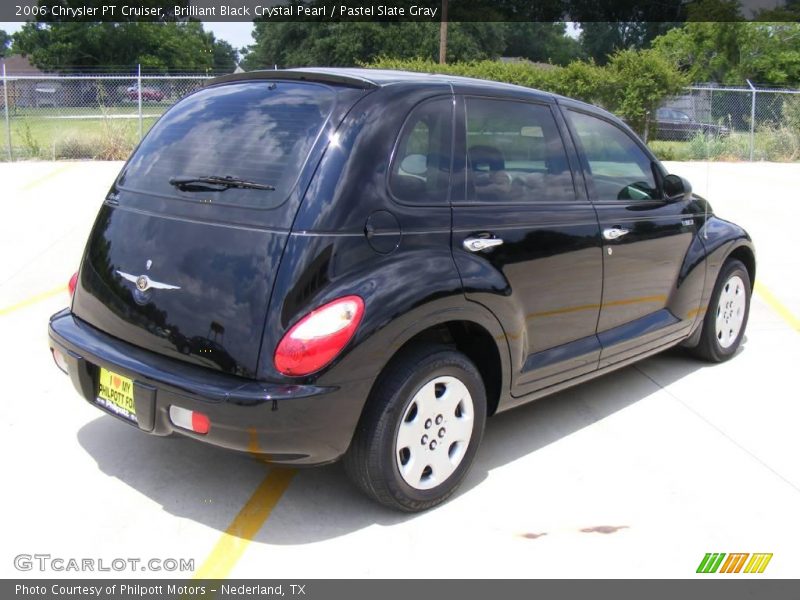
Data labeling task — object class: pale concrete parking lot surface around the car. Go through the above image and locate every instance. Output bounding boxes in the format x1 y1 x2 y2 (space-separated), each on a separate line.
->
0 162 800 579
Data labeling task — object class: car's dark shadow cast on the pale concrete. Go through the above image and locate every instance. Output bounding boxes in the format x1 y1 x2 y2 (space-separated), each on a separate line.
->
78 342 732 545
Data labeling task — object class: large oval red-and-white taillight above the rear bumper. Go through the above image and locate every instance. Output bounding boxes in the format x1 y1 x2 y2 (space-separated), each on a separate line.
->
274 296 364 377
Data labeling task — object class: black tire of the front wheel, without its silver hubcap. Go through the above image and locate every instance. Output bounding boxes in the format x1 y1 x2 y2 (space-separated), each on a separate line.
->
690 258 752 363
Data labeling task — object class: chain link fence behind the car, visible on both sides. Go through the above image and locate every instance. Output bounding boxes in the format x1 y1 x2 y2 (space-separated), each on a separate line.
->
0 69 800 161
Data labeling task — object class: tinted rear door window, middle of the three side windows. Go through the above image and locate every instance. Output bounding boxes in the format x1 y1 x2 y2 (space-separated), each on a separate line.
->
467 98 575 203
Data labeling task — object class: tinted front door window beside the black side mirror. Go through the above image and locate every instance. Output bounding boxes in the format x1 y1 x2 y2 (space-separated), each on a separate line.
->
568 111 657 200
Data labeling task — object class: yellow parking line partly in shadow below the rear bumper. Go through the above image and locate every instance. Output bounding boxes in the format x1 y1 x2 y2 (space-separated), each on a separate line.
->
194 468 295 579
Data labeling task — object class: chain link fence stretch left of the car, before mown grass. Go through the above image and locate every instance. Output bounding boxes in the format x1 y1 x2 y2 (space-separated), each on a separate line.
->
0 69 208 160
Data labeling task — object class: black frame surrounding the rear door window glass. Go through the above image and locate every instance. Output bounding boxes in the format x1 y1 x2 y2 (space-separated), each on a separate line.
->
451 93 587 207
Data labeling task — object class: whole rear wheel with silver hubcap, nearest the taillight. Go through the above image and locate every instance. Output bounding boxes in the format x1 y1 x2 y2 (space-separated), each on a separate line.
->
345 346 486 512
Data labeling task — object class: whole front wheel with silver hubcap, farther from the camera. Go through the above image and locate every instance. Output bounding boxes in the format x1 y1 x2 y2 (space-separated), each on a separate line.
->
692 259 752 362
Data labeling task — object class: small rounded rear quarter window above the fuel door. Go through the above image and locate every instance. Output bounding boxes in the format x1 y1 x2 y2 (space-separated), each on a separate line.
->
389 97 453 204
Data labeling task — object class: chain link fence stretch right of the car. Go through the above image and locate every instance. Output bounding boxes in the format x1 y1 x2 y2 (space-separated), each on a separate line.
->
648 82 800 162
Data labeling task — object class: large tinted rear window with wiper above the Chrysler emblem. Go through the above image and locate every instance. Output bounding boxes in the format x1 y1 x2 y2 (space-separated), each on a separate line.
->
119 81 335 208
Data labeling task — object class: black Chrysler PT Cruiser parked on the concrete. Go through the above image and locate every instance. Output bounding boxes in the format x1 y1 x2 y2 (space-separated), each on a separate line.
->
49 69 755 511
